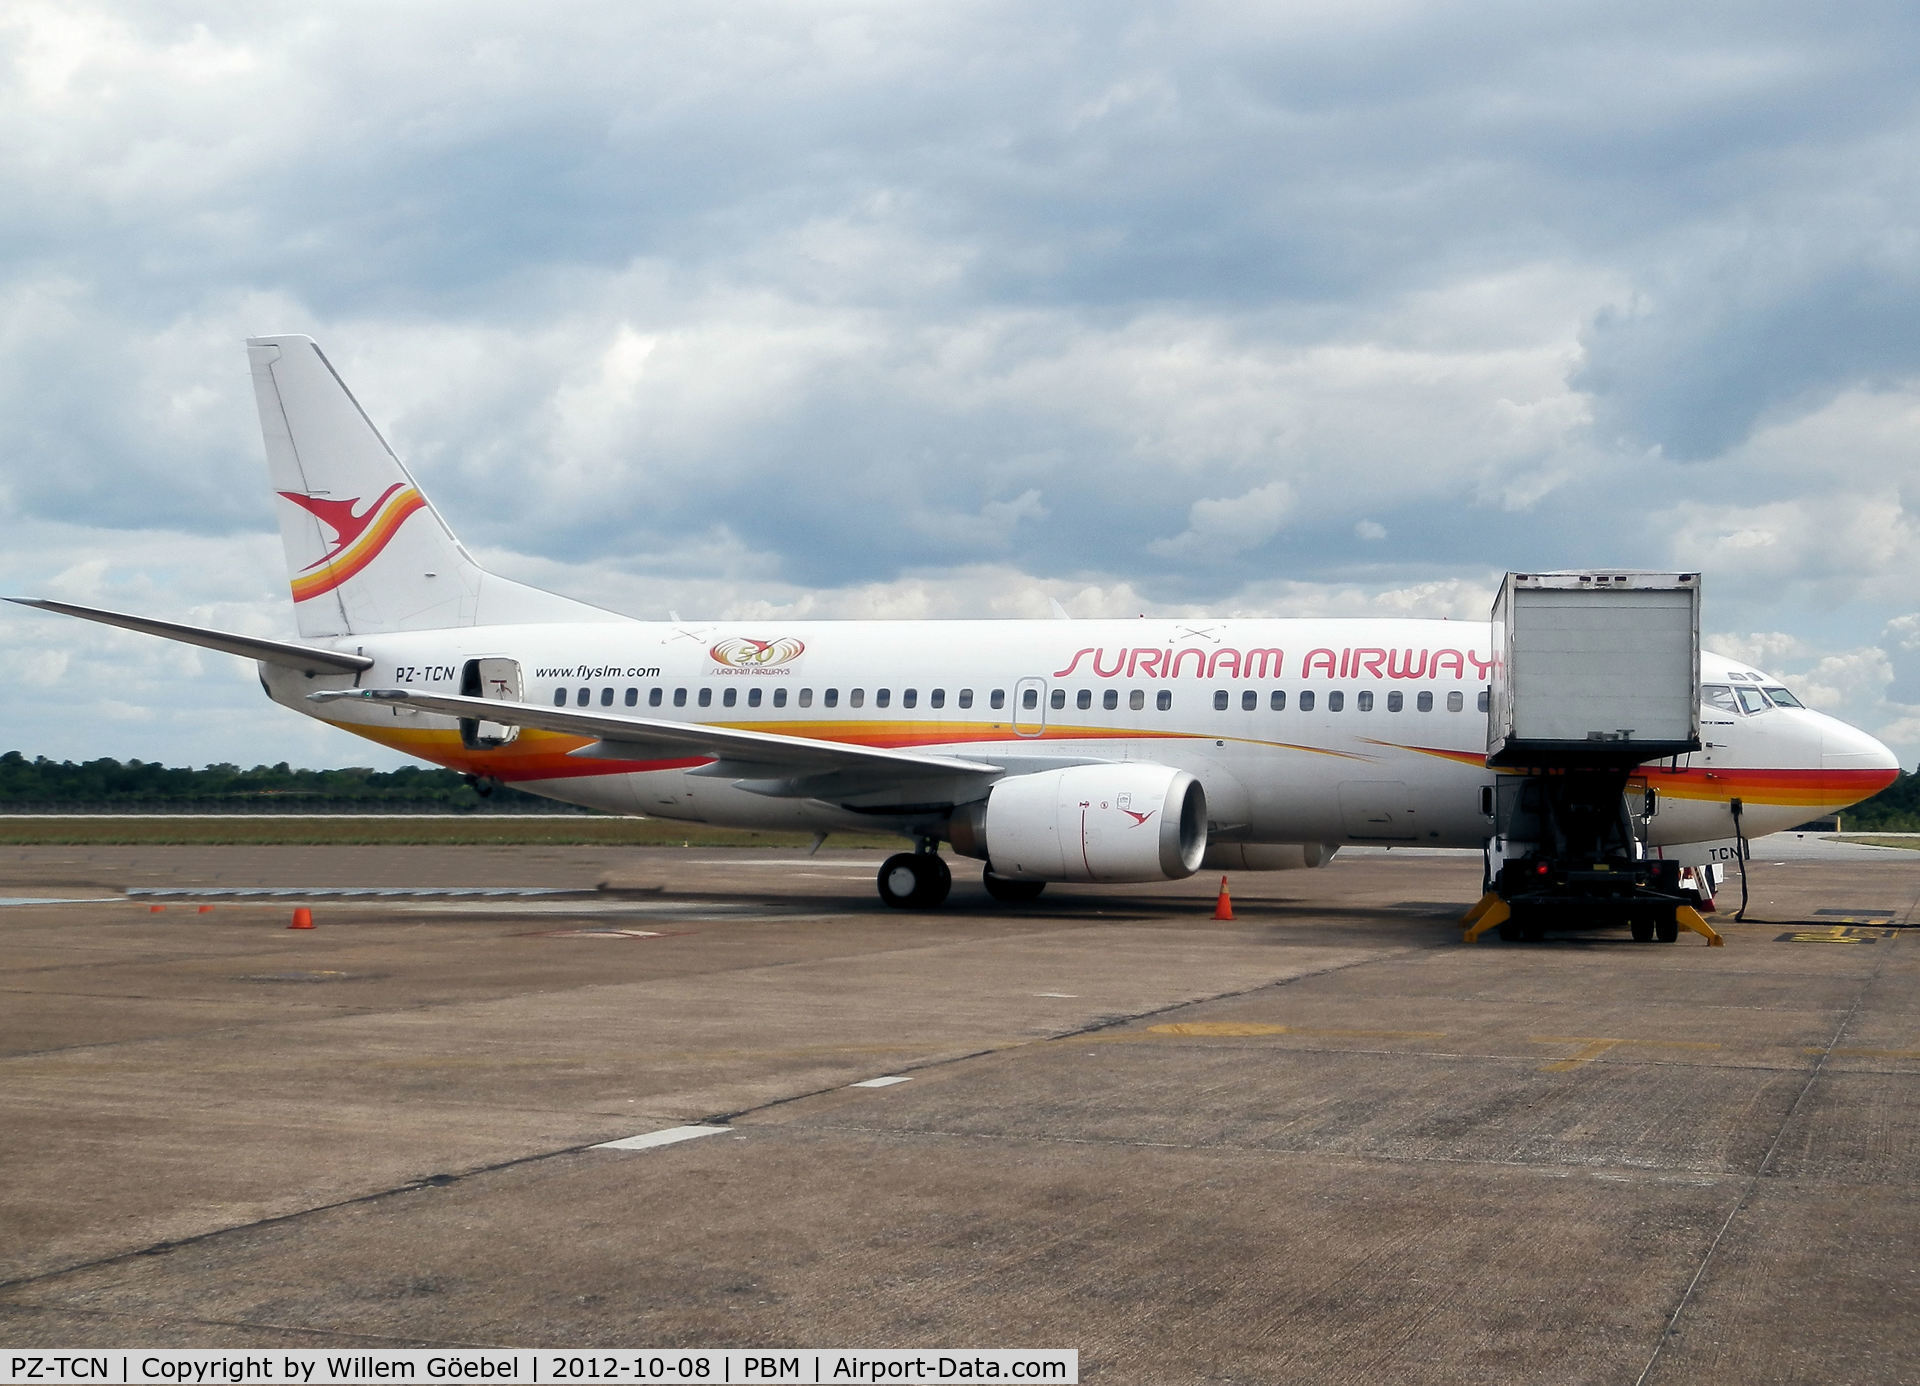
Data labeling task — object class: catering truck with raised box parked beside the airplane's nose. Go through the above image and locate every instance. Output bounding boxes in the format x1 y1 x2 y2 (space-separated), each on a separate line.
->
1467 572 1718 943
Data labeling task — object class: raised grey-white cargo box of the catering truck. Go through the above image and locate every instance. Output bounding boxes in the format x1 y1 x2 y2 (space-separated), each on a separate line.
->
1486 572 1699 768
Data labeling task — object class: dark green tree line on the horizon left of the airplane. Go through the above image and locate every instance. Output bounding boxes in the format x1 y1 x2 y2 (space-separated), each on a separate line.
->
0 751 586 814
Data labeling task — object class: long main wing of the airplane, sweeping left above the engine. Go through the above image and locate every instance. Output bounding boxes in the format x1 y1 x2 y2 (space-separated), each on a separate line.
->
307 689 1006 797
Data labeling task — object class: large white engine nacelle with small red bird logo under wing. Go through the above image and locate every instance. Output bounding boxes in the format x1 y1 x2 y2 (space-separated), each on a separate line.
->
950 764 1206 881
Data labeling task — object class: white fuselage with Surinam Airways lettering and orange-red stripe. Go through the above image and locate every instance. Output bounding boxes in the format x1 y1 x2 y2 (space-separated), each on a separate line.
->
263 618 1893 847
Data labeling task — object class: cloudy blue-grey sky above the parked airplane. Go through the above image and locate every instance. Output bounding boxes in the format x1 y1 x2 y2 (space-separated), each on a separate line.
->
0 0 1920 766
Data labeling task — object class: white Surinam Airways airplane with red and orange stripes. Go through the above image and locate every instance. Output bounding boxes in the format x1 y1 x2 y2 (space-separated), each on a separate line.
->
13 336 1899 917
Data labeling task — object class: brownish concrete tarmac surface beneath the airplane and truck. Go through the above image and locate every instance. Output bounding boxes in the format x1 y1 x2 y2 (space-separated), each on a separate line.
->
0 839 1920 1384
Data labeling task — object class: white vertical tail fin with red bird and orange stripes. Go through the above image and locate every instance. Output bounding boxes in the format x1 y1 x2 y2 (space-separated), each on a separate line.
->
246 336 616 637
